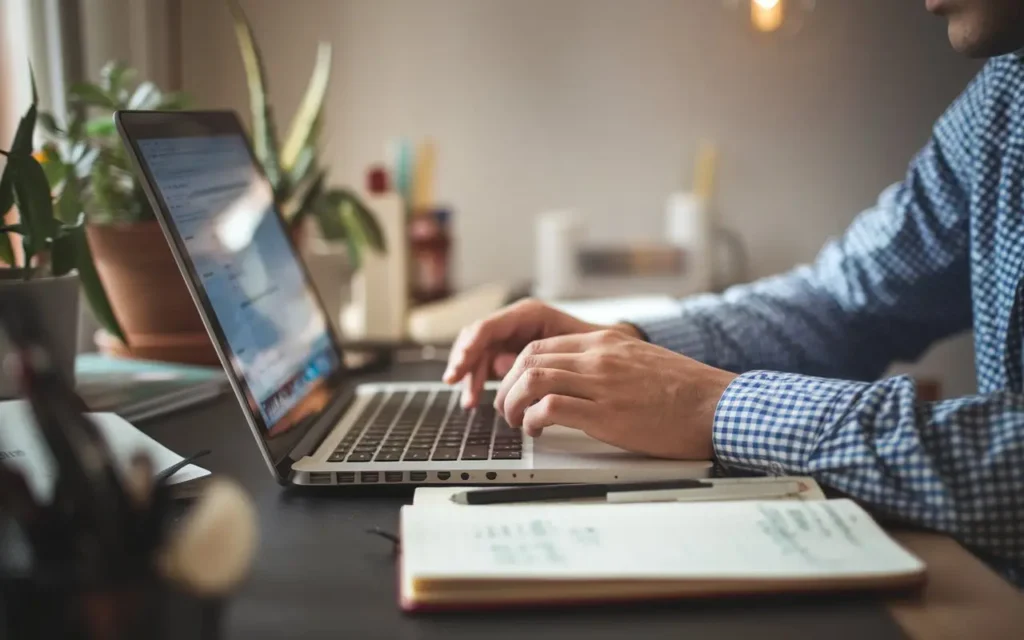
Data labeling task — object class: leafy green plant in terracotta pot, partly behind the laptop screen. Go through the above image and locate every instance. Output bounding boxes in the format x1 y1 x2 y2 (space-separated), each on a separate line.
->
41 62 218 365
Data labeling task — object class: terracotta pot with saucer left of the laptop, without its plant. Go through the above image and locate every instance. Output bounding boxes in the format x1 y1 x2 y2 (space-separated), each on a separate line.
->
87 221 219 366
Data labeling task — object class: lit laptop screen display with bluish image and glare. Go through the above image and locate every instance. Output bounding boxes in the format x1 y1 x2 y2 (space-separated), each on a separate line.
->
134 131 340 444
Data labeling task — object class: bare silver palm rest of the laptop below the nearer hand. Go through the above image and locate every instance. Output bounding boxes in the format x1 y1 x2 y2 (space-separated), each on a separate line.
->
534 427 680 469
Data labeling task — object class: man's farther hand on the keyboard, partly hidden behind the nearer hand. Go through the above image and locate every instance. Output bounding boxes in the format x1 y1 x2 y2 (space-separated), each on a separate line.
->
443 300 639 408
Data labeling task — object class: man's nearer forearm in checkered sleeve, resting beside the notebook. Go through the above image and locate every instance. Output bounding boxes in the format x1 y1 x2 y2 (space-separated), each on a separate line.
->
714 372 1024 584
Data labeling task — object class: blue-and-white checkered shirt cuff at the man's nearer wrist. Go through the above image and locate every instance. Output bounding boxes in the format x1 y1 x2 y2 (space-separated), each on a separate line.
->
713 371 868 475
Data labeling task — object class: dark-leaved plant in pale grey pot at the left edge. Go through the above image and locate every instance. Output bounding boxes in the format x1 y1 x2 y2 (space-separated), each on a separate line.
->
0 73 120 397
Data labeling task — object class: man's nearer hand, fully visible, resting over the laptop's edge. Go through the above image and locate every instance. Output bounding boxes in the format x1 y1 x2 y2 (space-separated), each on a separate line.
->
495 330 736 460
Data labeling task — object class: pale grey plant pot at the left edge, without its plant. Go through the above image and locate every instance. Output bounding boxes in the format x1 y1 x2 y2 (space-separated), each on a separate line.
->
0 268 79 398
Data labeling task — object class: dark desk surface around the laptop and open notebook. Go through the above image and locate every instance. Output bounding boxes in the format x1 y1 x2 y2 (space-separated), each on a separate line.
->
138 362 904 640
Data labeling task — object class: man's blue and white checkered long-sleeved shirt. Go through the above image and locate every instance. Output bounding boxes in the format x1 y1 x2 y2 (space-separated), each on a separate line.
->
635 55 1024 586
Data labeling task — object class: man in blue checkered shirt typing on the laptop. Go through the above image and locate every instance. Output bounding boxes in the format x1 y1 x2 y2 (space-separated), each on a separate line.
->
444 0 1024 585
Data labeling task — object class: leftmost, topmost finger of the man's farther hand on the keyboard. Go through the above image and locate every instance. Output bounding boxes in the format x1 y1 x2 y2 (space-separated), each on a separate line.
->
443 300 551 384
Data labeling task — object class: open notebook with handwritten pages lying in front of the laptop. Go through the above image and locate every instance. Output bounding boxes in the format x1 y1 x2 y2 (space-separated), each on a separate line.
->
399 500 925 611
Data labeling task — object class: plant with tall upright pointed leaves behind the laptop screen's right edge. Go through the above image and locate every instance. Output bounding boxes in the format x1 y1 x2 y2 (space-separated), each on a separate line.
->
227 0 386 322
